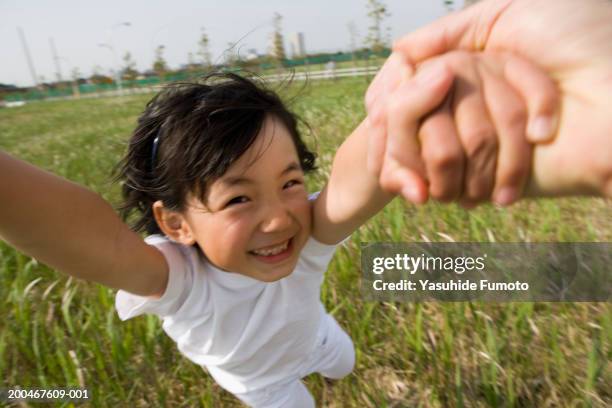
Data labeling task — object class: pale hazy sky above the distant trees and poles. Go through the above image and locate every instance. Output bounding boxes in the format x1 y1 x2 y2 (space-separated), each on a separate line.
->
0 0 462 86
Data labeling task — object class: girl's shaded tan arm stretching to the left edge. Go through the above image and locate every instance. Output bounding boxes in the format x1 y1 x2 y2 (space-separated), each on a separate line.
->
0 151 168 296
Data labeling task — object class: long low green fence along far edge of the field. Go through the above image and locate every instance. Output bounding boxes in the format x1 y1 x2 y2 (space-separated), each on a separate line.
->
4 50 389 104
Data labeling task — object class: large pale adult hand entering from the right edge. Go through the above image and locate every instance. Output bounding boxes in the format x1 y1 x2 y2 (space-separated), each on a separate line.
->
367 0 612 196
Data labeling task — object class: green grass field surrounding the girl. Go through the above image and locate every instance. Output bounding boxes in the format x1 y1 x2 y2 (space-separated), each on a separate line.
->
0 78 612 407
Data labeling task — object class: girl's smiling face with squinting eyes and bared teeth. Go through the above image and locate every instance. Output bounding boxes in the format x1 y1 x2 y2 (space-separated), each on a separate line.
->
178 117 311 282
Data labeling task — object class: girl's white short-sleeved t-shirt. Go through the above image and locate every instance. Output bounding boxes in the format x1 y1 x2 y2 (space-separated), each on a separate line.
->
115 235 336 393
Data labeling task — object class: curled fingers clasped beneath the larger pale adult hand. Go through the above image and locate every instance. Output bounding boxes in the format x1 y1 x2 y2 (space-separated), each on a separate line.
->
366 51 558 207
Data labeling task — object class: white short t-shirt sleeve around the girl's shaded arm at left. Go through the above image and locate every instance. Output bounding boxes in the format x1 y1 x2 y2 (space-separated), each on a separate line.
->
115 236 193 320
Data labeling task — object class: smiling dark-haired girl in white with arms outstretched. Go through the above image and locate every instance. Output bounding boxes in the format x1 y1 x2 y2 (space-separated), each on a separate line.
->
0 55 556 407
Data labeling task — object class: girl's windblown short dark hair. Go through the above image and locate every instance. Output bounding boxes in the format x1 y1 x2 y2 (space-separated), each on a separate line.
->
115 73 316 234
